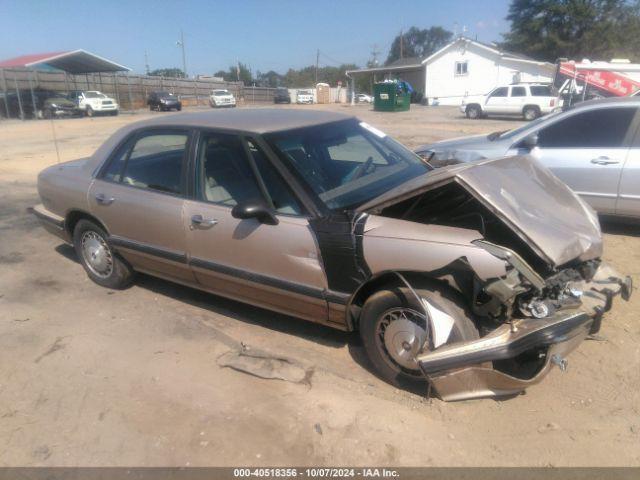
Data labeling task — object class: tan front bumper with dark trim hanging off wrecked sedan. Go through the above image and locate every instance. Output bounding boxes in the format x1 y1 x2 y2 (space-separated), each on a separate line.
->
417 264 632 401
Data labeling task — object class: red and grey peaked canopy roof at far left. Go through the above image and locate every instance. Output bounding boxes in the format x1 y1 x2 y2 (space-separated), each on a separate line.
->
0 49 131 74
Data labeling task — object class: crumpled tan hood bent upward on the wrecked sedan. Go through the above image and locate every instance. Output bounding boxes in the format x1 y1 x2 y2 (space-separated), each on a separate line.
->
358 156 602 267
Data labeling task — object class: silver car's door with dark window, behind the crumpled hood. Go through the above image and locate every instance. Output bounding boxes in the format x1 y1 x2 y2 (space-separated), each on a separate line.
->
508 106 637 214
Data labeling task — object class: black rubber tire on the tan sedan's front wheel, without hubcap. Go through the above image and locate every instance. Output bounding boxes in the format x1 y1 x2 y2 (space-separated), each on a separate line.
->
359 286 479 389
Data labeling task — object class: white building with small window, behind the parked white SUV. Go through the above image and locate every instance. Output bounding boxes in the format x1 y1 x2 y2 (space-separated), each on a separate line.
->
422 37 555 105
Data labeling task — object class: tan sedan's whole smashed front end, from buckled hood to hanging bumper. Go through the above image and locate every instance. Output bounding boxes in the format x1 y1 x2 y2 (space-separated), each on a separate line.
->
363 157 632 400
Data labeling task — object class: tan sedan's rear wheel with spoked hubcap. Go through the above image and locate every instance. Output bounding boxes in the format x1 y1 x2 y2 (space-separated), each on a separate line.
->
73 220 134 289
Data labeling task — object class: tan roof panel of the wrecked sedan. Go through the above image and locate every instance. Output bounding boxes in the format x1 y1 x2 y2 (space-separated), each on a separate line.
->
122 108 354 134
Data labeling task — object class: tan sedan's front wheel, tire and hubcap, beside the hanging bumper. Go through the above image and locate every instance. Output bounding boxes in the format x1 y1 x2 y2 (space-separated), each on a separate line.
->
359 287 479 388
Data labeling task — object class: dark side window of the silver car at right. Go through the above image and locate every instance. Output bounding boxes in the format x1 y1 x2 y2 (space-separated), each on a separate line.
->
538 108 636 148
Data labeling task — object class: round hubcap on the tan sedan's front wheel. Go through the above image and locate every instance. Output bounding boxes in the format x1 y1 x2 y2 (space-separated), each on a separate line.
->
376 308 427 372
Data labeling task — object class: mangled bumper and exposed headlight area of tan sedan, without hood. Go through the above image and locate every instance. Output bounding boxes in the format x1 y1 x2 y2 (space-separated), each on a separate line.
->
417 249 632 401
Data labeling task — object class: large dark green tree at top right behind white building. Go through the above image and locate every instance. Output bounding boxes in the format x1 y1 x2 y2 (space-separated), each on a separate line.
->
501 0 640 62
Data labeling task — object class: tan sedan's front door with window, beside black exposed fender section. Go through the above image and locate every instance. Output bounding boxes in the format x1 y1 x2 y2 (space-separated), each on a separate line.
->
184 132 328 321
